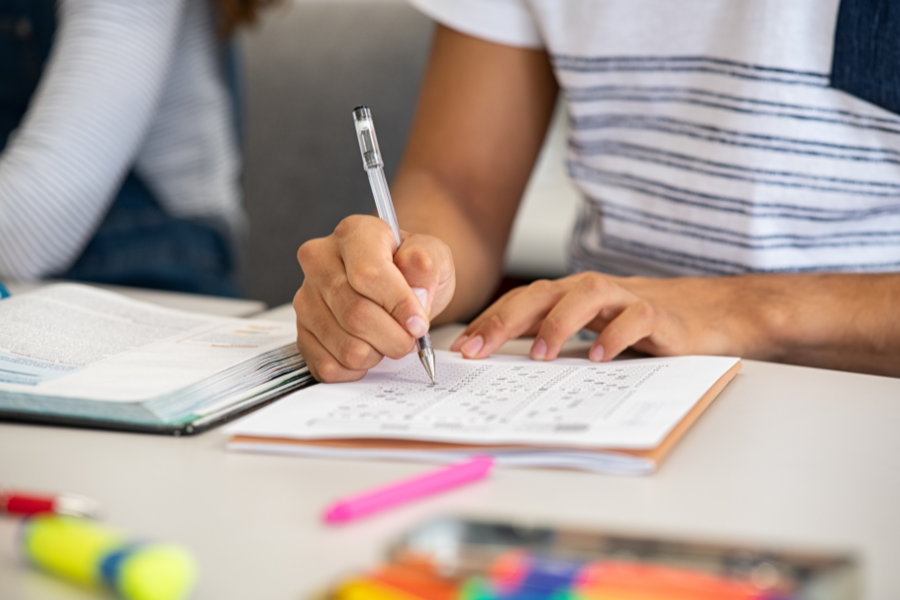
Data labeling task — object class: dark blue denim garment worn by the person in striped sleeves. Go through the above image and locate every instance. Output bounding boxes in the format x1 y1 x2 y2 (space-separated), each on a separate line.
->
0 0 239 296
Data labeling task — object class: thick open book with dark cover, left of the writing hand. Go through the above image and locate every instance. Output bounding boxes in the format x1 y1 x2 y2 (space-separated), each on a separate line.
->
0 284 311 434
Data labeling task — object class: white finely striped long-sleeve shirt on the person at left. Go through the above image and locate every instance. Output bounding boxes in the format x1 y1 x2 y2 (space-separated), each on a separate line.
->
0 0 244 280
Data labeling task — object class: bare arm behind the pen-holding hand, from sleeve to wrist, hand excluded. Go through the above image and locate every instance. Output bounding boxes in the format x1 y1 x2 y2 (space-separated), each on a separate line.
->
392 26 558 322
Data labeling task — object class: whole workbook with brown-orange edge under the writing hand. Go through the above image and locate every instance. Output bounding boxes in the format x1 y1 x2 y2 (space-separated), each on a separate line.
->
225 351 740 474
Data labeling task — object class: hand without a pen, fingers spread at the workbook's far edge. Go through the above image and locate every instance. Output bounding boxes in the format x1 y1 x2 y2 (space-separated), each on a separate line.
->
451 272 762 362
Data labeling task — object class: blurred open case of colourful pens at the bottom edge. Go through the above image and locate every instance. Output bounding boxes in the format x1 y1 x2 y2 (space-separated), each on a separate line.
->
326 518 861 600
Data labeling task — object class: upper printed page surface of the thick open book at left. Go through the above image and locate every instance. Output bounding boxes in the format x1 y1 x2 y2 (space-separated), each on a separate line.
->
0 284 296 402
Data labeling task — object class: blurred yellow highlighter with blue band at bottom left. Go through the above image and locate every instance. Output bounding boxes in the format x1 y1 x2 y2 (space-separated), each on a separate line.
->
20 515 196 600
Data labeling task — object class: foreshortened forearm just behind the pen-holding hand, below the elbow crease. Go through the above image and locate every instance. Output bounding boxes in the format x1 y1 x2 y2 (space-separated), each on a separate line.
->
392 166 508 324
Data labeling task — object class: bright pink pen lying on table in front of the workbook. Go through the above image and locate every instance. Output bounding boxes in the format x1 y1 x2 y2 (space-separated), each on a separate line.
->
323 456 494 524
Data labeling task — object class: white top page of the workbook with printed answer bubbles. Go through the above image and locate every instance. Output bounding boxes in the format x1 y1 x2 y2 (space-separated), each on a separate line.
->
226 351 738 449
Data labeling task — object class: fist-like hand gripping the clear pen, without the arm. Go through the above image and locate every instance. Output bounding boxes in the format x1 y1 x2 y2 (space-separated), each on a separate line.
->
294 215 456 382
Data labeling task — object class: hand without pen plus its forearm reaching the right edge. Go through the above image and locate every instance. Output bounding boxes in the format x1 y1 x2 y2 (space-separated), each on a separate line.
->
451 272 900 375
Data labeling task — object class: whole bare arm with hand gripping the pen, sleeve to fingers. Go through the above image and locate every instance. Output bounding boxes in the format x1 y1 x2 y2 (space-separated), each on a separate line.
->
294 26 557 381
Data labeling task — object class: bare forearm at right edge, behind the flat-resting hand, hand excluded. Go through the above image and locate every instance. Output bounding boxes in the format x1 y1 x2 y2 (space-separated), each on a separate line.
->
622 274 900 376
